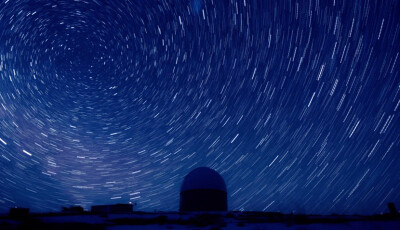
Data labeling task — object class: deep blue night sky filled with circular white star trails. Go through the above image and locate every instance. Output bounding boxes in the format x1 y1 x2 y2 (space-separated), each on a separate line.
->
0 0 400 214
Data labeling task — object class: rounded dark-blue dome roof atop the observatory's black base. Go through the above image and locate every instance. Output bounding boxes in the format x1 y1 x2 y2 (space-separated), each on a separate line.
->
181 167 226 192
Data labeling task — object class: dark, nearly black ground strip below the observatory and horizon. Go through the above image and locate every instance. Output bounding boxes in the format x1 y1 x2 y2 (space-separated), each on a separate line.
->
0 212 400 230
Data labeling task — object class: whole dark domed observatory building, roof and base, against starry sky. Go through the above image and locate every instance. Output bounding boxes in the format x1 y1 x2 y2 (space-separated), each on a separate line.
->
179 167 228 212
